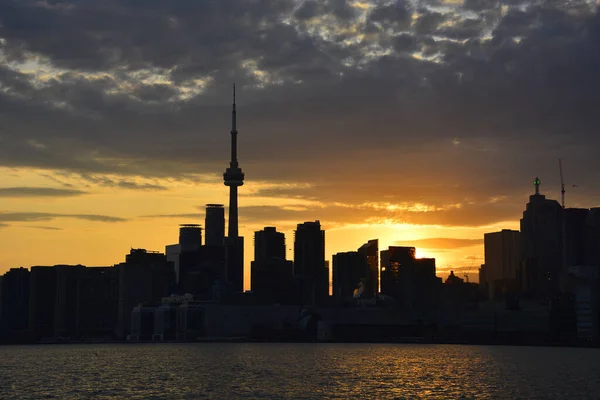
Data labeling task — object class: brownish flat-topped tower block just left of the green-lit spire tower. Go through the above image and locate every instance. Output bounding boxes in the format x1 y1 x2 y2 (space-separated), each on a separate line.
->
480 229 521 300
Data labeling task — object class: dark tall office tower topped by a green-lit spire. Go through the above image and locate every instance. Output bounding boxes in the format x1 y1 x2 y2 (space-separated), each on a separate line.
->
520 178 563 302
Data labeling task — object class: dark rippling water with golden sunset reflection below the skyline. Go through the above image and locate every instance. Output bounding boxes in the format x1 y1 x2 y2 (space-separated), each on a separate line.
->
0 343 600 400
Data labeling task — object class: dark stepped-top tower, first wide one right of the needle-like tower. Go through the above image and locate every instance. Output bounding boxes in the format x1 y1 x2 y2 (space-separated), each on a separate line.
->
250 227 295 303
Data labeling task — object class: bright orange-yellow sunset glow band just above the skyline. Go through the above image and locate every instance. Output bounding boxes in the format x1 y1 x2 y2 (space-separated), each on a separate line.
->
0 169 515 289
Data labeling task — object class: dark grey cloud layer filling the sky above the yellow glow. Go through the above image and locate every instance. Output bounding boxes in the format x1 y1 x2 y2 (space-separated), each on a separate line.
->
0 0 600 216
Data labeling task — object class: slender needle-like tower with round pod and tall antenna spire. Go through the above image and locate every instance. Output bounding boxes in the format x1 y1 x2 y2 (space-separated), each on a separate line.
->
223 84 244 292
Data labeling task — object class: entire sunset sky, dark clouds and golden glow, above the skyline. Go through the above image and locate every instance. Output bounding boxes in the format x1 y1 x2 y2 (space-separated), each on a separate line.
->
0 0 600 289
